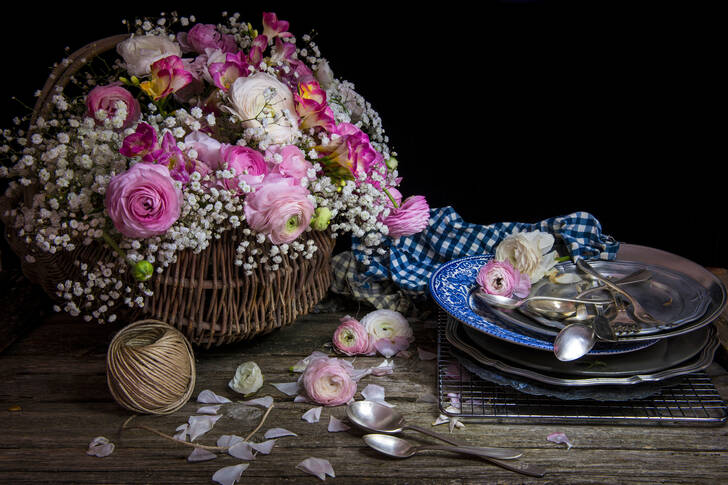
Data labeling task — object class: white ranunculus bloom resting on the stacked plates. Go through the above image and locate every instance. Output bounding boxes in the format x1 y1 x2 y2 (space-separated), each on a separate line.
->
495 231 557 284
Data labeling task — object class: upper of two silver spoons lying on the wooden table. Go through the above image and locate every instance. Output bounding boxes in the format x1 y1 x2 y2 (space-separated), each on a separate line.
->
346 401 523 460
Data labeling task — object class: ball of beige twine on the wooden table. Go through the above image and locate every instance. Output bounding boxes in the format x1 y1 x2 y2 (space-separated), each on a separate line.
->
106 320 195 414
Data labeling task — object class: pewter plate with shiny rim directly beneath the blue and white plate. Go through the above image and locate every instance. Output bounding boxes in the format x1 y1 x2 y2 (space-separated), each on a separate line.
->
445 319 719 387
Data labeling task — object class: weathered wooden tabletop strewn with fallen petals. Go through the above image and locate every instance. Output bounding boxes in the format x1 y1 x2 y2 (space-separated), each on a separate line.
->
0 271 728 485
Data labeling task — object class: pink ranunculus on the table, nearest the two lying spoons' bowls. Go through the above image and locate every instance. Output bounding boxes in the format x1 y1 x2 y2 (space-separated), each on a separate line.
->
300 357 356 406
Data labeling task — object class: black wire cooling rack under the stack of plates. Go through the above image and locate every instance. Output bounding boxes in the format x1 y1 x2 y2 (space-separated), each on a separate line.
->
437 312 728 426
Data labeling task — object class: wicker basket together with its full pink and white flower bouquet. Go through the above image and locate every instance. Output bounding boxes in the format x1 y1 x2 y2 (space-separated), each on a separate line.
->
0 13 429 346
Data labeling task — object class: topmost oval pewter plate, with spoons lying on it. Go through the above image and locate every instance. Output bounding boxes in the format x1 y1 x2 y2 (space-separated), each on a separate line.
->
492 261 711 338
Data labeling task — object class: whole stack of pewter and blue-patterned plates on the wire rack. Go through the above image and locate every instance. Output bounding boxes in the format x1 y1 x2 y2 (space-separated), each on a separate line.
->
430 244 726 397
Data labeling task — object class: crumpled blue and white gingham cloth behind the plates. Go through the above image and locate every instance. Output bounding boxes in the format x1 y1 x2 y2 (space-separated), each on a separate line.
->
332 207 619 312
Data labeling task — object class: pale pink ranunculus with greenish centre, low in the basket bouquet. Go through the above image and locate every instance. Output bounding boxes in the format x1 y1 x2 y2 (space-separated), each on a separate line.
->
245 174 314 244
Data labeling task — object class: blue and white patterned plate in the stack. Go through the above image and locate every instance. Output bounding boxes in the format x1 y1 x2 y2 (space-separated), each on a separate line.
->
429 254 656 355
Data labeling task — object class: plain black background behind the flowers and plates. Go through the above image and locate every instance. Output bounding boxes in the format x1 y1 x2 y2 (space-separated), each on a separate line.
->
0 1 728 267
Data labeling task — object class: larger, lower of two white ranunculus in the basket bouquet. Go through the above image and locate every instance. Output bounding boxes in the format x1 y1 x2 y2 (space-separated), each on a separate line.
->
229 72 298 145
